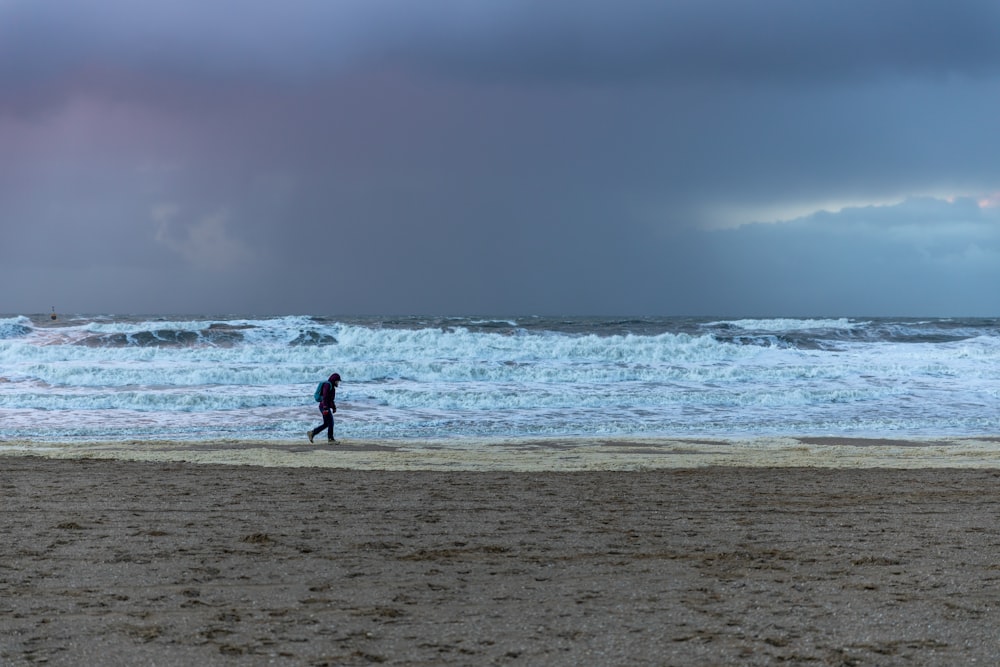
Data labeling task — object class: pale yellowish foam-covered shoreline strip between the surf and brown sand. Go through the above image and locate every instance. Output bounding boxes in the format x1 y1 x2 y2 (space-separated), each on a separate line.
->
0 435 1000 472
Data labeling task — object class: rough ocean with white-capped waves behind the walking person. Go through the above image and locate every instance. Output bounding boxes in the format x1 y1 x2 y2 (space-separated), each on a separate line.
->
0 315 1000 468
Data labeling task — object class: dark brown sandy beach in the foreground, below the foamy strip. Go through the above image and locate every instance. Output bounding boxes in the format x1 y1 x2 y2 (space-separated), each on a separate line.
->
0 456 1000 666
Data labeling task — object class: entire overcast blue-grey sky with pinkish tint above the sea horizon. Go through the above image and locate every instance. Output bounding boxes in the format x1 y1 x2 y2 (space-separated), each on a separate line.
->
0 0 1000 316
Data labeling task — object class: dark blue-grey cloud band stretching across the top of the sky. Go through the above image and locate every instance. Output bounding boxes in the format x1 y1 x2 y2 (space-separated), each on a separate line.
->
7 0 1000 98
